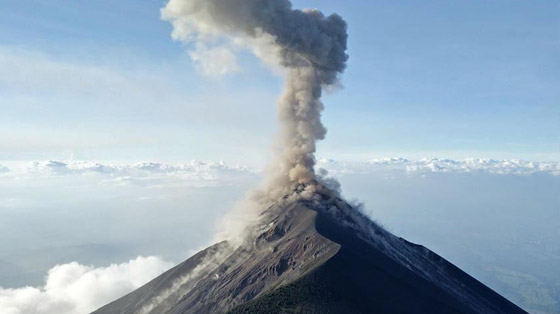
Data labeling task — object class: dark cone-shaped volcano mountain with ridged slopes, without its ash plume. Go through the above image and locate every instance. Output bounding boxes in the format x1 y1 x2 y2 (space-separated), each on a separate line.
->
94 191 526 314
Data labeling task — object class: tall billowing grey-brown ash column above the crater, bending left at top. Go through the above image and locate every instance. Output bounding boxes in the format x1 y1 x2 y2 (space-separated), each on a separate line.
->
162 0 348 198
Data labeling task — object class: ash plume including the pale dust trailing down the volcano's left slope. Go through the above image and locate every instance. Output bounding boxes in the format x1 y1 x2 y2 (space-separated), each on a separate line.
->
123 0 348 313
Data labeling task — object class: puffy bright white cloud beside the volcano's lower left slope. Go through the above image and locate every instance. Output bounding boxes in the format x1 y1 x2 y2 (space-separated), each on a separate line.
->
0 256 172 314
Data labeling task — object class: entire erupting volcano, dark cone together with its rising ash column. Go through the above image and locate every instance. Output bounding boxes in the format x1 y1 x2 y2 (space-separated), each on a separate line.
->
107 0 525 314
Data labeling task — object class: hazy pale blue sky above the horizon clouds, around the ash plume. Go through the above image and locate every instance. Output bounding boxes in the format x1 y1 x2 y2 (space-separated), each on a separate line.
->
0 0 560 164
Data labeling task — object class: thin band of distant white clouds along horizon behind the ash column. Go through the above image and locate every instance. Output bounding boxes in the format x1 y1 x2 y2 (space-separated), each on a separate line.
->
0 157 560 179
